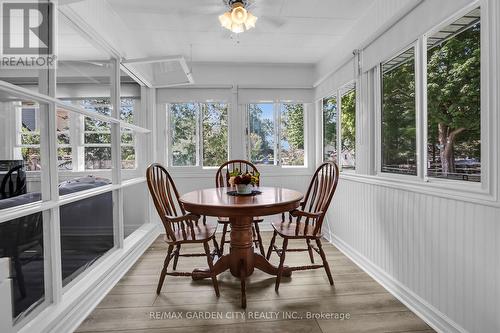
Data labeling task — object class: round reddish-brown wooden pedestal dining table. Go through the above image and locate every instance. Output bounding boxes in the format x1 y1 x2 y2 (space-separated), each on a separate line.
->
180 187 303 308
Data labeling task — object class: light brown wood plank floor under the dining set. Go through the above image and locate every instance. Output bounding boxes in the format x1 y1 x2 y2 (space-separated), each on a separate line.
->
77 232 434 333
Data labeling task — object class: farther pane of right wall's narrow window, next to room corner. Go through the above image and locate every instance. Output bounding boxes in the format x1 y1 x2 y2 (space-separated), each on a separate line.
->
323 96 337 161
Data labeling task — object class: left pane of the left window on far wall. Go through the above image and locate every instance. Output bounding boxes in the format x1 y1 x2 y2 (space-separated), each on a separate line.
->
170 103 198 166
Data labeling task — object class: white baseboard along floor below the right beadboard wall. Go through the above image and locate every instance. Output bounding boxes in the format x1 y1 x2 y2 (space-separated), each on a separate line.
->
325 233 467 333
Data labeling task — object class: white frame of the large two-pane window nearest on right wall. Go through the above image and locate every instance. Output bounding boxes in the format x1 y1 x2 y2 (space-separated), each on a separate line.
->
366 1 499 206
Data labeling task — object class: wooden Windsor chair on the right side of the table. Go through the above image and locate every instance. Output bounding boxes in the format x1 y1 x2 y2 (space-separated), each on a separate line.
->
266 162 339 291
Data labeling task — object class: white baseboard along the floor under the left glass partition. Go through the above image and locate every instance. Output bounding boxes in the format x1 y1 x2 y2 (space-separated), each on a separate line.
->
19 225 160 333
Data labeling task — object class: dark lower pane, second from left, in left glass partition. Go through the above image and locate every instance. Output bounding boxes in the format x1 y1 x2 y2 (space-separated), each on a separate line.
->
60 192 114 285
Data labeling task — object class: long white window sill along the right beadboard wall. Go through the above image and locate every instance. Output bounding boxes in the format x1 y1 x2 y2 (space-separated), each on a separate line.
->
340 172 500 207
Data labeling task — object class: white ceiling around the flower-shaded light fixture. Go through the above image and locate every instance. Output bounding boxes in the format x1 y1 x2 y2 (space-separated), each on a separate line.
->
107 0 378 63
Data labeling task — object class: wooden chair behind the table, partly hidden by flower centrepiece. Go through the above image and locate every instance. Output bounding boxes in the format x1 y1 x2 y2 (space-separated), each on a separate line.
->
215 160 266 256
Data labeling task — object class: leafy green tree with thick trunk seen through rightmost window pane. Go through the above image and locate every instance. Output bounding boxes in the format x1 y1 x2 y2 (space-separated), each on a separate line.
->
427 23 481 176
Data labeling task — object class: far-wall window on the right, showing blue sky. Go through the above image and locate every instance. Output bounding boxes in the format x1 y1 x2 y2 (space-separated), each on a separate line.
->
247 103 305 166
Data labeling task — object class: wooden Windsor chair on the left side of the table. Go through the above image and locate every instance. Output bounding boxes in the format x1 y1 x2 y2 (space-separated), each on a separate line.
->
146 163 219 297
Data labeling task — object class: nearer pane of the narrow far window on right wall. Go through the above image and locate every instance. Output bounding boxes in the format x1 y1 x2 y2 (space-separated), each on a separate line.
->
340 87 356 169
